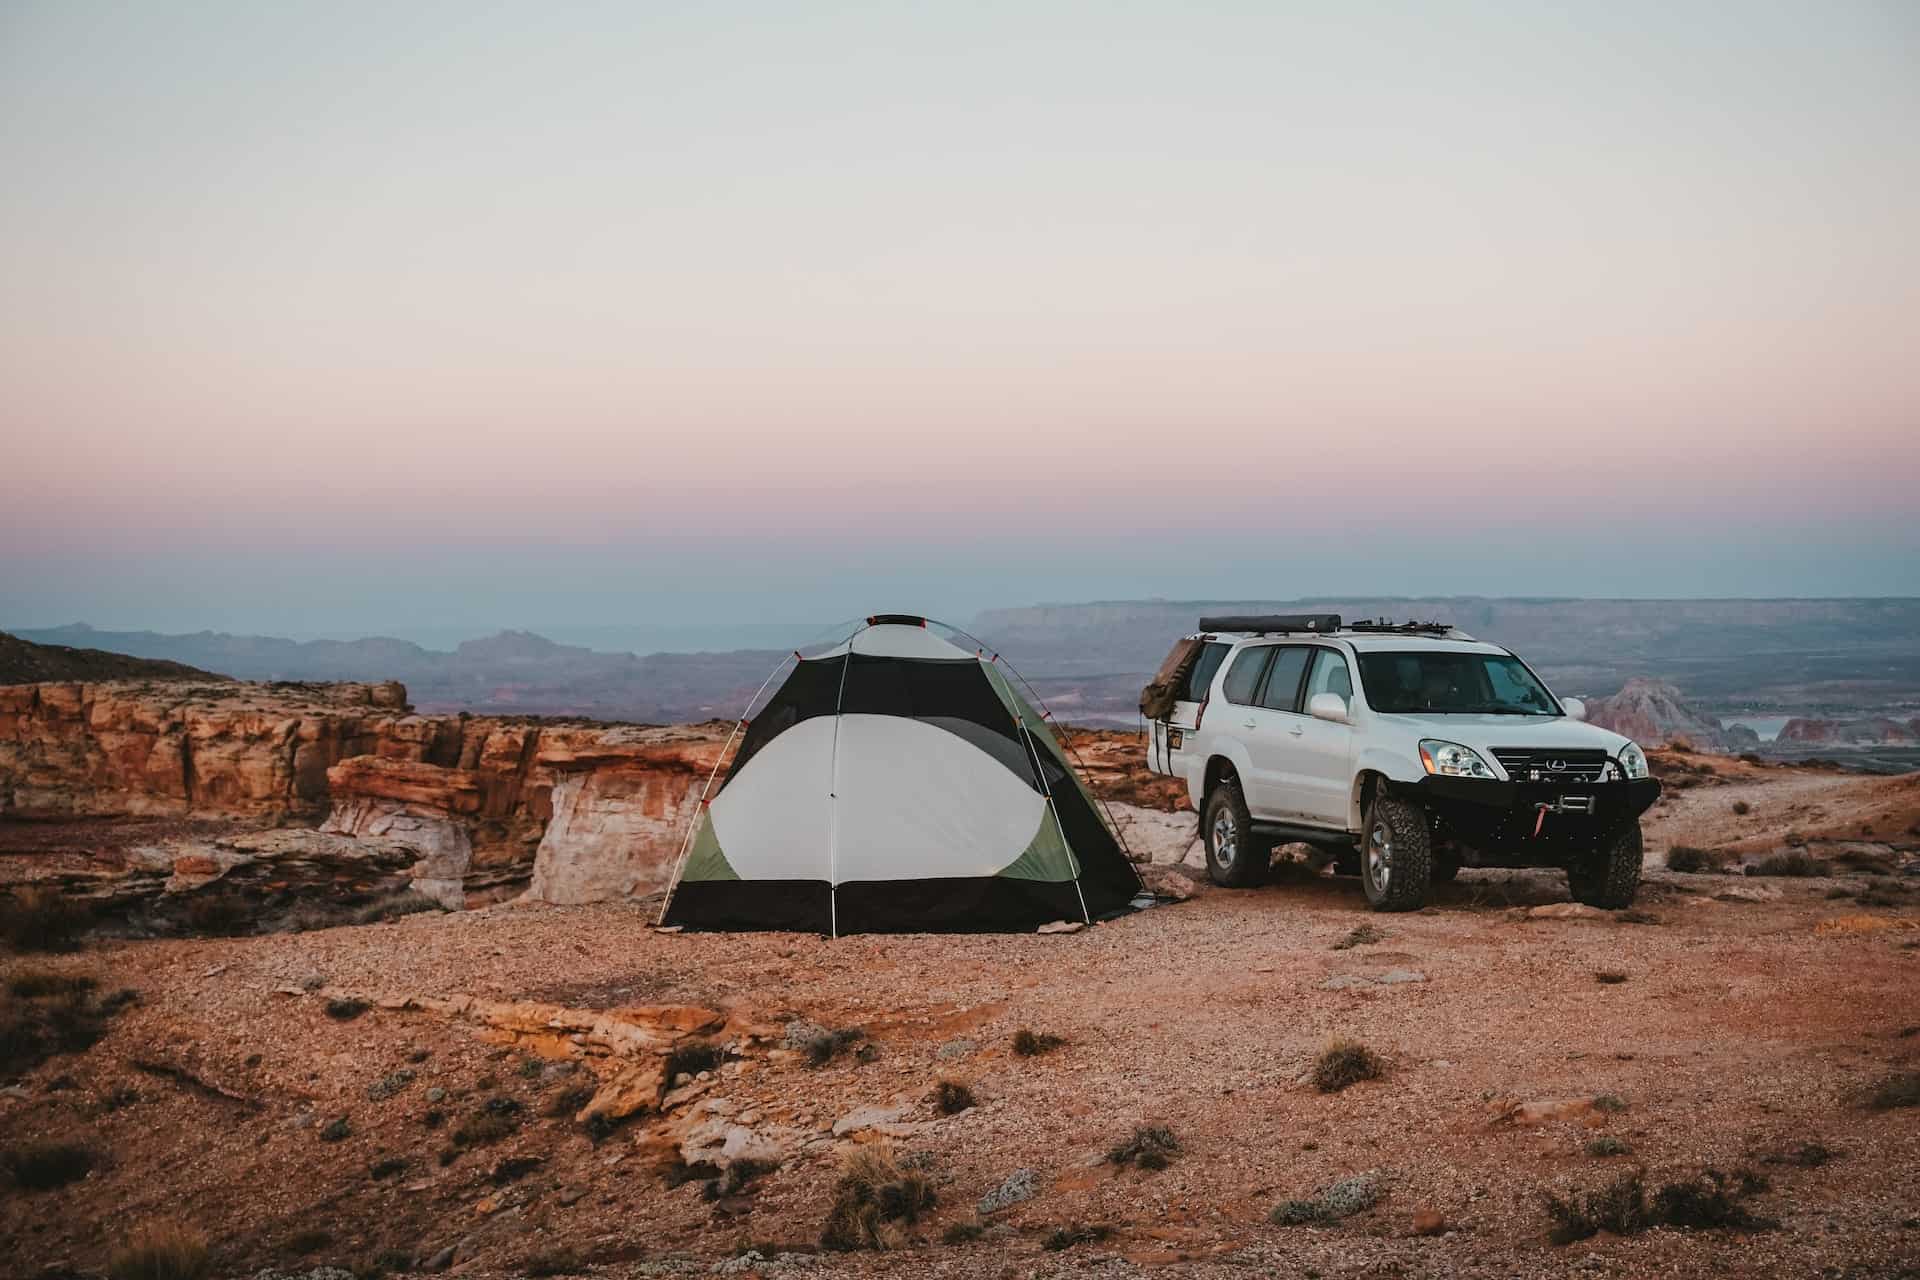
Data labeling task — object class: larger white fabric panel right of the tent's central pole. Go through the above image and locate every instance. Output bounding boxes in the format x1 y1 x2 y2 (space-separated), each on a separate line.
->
833 717 1046 885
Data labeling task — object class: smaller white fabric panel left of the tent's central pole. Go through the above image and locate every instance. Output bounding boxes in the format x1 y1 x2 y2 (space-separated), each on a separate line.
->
710 716 833 881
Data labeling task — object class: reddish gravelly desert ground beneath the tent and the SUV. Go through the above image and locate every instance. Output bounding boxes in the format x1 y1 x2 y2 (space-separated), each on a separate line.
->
0 752 1920 1276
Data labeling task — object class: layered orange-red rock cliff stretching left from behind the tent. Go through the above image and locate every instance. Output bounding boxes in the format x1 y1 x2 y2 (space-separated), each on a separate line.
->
0 681 728 906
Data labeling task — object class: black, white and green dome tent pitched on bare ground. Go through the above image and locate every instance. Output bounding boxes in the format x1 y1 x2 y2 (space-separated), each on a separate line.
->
660 614 1140 936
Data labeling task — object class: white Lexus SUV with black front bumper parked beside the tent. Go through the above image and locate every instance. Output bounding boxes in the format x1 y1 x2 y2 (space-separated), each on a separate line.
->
1140 614 1661 912
